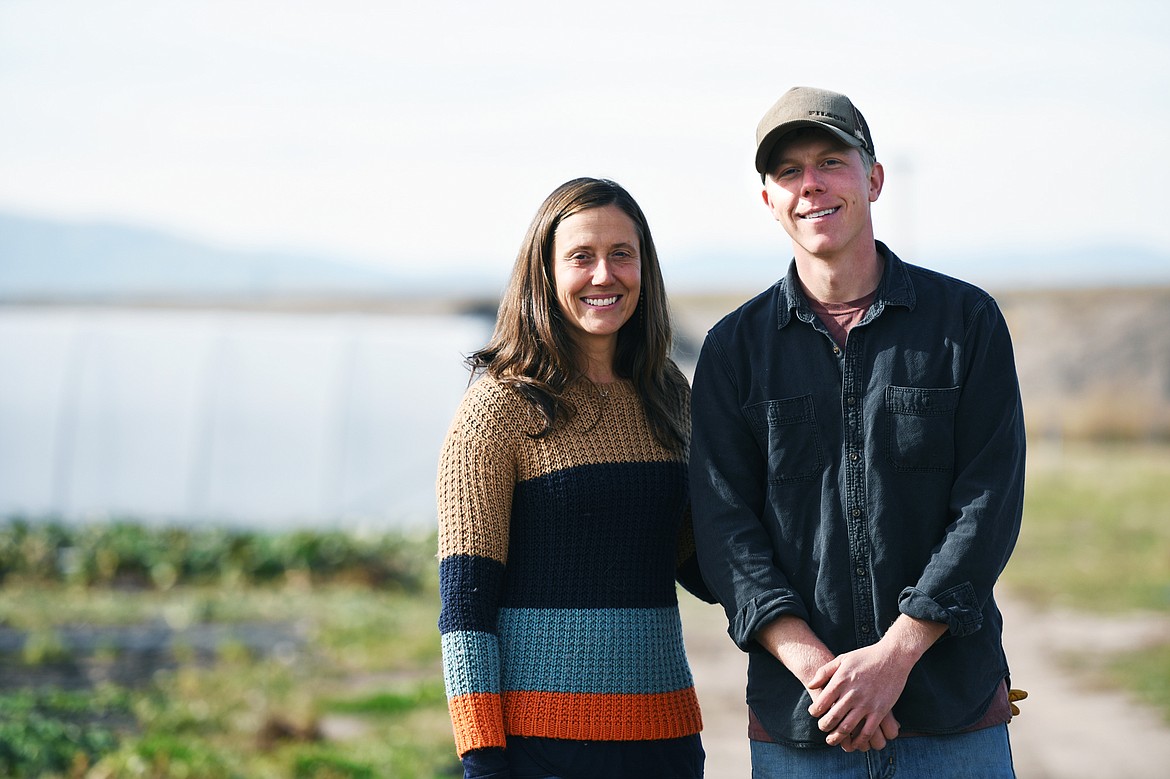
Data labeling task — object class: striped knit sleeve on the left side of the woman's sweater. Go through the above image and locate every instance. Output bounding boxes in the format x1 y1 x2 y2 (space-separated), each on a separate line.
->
435 379 515 756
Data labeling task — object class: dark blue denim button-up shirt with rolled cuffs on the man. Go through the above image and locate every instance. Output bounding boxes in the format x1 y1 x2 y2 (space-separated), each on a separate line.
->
690 243 1025 745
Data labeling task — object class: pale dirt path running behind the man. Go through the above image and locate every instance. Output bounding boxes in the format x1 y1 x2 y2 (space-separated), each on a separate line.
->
682 593 1170 779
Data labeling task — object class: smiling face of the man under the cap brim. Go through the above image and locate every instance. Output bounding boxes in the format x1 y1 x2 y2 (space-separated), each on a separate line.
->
763 131 885 261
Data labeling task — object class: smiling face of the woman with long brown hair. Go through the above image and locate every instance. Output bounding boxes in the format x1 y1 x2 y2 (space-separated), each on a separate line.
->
552 205 642 361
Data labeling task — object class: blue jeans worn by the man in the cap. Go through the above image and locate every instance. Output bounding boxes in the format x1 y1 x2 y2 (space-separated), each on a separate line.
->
751 725 1016 779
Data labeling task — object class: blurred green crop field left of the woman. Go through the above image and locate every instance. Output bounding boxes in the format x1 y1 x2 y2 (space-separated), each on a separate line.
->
0 523 461 779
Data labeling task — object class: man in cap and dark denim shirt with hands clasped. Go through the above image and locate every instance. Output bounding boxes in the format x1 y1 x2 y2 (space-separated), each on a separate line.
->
690 87 1024 779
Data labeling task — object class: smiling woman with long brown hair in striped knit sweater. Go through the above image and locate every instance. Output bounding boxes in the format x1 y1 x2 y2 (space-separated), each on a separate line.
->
436 179 710 779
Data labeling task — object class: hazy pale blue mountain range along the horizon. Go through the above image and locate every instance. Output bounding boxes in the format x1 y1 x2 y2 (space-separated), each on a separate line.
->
0 214 1170 301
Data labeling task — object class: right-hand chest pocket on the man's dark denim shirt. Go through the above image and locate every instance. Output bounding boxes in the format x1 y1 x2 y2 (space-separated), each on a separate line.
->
886 386 961 471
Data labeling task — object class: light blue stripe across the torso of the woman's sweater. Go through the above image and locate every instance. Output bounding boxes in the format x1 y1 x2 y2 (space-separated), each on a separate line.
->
498 607 694 694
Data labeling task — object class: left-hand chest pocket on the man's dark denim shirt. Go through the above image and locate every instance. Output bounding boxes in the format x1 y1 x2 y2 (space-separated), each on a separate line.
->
743 395 825 484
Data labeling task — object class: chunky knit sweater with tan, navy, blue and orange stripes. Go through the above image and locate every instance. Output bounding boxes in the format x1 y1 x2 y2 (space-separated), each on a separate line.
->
436 377 702 756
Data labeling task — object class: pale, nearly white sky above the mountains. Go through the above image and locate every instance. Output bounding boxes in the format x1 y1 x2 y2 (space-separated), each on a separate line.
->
0 0 1170 285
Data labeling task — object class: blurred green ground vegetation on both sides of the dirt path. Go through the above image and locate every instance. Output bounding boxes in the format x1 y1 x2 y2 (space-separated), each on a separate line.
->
0 444 1170 779
